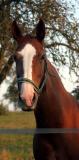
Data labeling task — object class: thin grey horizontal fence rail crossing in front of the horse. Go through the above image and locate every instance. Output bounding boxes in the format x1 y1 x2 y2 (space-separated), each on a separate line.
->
0 128 79 134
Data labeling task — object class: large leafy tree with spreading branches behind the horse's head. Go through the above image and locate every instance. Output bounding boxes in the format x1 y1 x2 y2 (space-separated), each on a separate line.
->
0 0 79 104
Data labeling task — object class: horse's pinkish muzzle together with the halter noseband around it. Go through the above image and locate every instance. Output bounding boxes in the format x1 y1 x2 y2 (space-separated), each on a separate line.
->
17 73 47 111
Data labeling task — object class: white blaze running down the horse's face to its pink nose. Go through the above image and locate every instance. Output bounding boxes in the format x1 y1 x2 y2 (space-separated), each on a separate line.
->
19 44 36 106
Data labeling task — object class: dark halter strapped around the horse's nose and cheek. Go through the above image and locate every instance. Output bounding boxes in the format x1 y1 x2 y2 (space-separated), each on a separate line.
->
17 59 48 94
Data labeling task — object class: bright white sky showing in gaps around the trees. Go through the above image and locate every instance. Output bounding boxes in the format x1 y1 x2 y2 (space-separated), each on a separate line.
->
0 0 79 110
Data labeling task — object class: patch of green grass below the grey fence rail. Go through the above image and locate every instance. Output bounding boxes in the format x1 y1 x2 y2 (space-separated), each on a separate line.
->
0 135 33 160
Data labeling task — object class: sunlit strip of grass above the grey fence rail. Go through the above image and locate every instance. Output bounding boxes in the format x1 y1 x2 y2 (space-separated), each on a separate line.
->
0 112 35 128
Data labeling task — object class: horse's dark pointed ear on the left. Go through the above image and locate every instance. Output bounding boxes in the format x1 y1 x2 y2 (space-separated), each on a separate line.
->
12 21 22 41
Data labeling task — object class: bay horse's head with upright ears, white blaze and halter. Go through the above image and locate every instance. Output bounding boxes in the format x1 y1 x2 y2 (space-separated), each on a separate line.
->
12 19 46 108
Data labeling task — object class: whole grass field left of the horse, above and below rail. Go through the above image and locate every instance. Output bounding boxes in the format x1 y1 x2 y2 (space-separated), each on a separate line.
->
0 112 35 160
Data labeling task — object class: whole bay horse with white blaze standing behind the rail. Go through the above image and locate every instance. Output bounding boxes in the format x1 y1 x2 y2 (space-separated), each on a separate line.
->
12 19 79 160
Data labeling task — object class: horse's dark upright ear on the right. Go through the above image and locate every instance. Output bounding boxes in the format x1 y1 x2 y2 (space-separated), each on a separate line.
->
36 19 45 41
